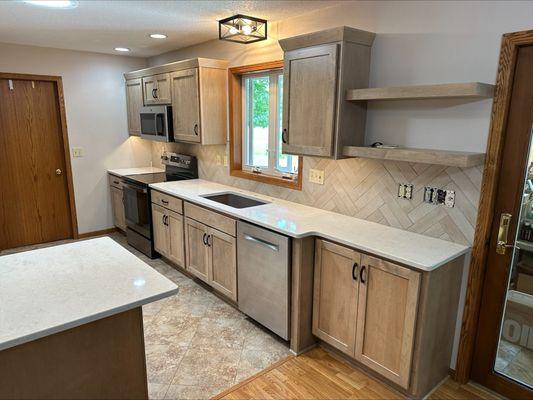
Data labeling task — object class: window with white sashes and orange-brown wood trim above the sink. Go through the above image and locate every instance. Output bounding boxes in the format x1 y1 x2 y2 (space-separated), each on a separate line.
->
230 62 302 189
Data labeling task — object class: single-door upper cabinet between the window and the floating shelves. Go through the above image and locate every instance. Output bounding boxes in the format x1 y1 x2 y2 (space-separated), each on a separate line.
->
279 27 375 159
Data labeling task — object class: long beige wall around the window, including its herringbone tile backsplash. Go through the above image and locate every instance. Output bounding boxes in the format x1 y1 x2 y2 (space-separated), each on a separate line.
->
148 1 533 244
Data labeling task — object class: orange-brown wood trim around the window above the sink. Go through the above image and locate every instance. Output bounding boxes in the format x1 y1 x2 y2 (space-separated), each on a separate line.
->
228 60 303 190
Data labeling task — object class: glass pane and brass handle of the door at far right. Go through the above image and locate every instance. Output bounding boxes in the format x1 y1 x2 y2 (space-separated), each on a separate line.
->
494 125 533 388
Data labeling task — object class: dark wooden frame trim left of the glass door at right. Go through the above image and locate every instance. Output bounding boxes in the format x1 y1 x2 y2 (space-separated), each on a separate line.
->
455 30 533 383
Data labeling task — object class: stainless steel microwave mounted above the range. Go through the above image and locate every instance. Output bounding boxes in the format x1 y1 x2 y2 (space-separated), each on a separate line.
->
140 106 174 142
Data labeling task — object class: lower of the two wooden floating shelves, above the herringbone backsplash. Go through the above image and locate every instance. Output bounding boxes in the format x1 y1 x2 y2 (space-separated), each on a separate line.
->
343 146 485 168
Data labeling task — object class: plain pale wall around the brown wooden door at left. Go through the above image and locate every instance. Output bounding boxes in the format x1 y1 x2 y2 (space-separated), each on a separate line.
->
0 43 151 233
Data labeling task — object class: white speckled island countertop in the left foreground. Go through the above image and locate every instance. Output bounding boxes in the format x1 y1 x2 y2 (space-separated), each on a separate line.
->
0 237 178 351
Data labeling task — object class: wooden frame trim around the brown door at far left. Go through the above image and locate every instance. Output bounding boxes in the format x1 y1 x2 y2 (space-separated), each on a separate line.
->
0 72 79 239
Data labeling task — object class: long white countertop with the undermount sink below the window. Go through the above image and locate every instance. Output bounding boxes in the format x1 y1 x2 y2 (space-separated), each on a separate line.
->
150 179 470 271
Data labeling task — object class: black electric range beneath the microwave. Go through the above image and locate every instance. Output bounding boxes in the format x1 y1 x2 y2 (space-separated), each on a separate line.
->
123 153 198 258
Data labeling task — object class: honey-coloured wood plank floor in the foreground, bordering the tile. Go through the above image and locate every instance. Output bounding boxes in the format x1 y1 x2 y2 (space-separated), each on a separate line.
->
214 348 499 400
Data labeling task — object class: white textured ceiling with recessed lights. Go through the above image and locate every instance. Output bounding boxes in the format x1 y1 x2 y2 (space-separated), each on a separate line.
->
0 0 339 57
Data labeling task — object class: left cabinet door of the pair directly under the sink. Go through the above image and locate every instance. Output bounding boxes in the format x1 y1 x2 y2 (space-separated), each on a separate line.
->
185 218 209 282
